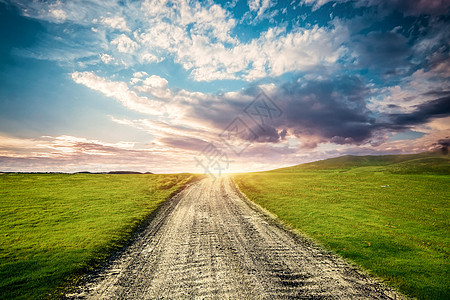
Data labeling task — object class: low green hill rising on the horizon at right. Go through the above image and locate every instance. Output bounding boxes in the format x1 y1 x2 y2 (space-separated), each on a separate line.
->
273 151 450 175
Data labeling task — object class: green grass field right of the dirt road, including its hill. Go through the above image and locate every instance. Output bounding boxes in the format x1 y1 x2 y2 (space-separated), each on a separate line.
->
234 153 450 299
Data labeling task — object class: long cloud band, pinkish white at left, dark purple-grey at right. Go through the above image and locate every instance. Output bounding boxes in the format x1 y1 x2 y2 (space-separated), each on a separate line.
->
72 62 450 159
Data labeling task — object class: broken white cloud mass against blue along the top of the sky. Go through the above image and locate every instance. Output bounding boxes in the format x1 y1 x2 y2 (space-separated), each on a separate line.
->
13 0 347 81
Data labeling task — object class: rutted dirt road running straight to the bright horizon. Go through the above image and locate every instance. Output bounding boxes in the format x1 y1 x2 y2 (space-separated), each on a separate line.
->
68 177 399 299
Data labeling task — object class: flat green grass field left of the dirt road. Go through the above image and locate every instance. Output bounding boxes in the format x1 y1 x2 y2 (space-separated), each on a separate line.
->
0 174 194 299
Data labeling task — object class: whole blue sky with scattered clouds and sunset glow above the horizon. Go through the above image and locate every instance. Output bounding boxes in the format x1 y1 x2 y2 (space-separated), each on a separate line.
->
0 0 450 174
